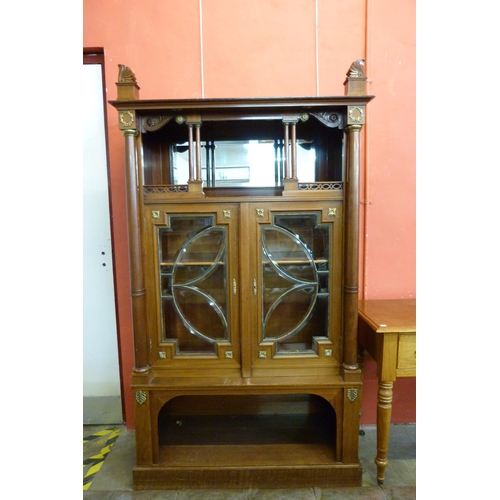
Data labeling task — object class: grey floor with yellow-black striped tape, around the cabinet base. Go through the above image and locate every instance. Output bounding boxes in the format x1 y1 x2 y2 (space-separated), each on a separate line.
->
83 424 416 500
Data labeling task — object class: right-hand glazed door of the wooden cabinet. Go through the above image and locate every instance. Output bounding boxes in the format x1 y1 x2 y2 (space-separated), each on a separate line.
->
246 201 342 376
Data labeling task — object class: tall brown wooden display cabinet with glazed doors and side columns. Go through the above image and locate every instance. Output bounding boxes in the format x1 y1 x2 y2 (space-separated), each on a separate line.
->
111 60 373 489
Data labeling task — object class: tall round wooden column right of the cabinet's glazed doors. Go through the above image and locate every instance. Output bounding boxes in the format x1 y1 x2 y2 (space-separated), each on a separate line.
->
343 125 361 370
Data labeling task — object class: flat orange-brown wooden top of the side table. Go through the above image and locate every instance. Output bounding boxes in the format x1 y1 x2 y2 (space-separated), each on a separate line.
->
358 299 417 334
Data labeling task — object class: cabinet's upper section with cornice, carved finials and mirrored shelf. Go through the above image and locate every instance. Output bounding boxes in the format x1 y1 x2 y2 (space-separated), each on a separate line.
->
109 63 374 200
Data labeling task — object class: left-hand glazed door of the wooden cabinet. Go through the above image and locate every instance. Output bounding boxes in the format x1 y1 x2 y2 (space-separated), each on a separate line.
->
146 204 240 376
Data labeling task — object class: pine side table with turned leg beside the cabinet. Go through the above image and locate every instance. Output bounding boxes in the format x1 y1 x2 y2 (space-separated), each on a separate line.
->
358 299 417 484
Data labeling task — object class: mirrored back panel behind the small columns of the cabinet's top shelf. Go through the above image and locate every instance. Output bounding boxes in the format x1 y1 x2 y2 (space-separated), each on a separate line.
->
142 117 344 188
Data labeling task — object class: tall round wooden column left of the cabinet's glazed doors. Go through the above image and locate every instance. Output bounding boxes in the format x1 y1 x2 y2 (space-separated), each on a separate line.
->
123 129 149 373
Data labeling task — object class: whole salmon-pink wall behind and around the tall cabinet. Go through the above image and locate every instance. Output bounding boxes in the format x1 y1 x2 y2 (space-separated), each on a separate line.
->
83 0 416 427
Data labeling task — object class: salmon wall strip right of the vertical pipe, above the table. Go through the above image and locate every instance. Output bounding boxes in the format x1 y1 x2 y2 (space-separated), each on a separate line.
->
361 0 416 299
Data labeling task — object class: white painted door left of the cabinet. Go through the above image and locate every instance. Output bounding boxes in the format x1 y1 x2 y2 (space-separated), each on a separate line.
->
81 60 123 424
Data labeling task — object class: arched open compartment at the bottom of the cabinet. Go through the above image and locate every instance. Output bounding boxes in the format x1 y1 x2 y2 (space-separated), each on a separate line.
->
154 394 336 467
